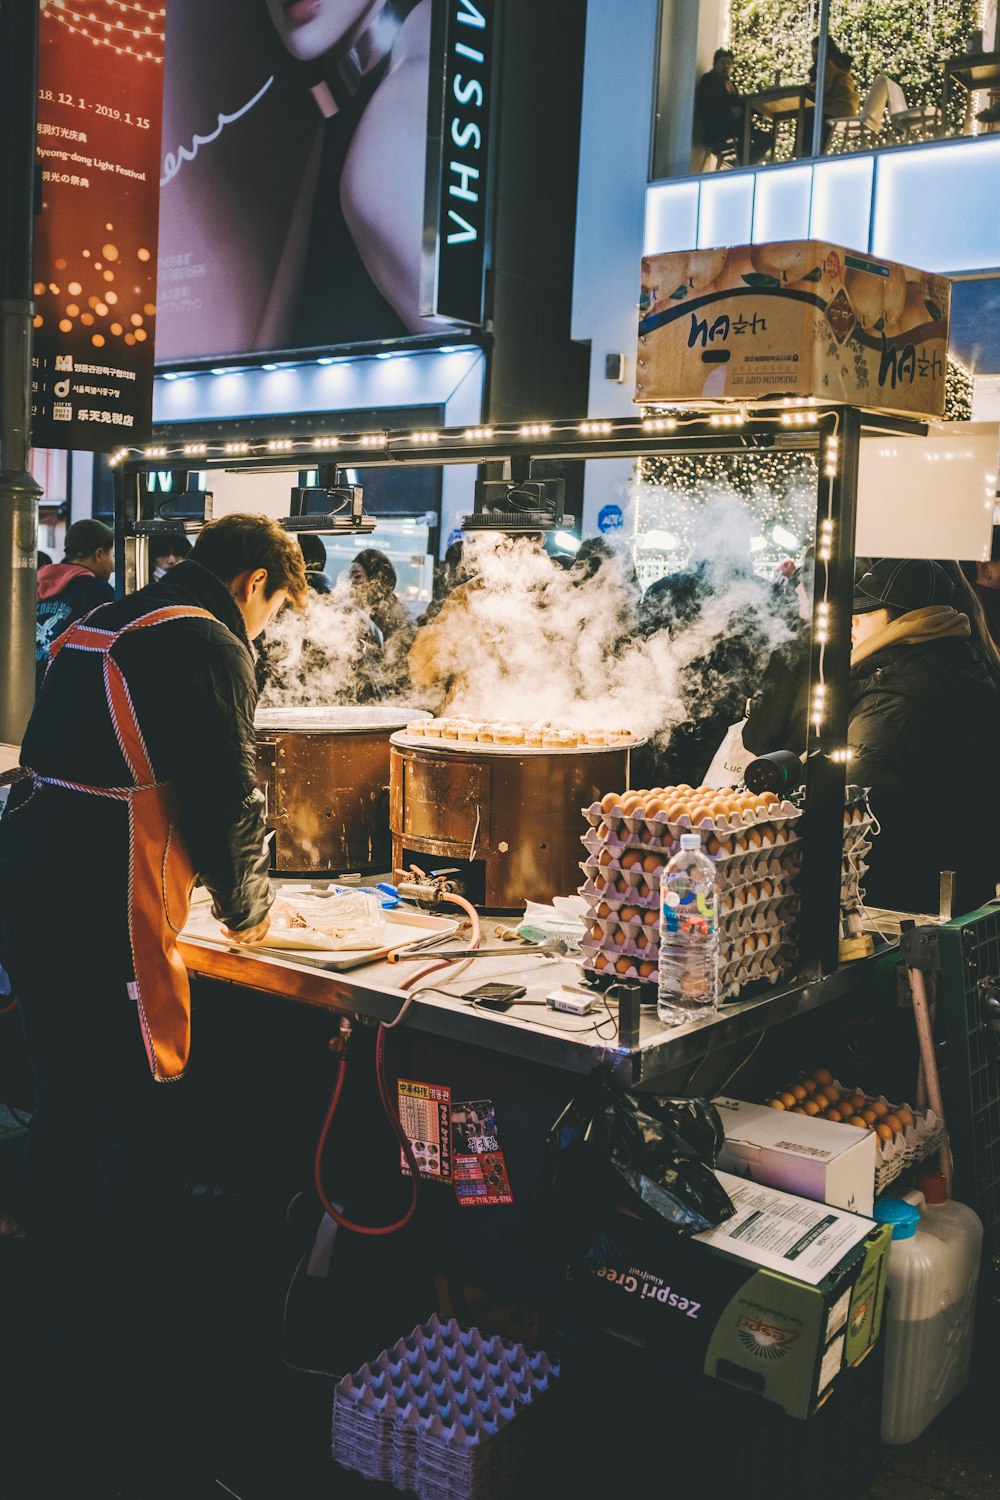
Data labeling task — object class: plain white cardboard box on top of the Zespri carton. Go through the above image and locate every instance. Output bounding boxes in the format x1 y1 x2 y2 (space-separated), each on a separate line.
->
712 1100 876 1214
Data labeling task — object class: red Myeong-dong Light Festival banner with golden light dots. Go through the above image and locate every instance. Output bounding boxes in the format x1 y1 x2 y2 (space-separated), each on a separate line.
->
31 0 165 453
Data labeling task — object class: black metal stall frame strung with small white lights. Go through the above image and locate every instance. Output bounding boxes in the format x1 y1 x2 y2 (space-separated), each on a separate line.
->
111 399 927 1008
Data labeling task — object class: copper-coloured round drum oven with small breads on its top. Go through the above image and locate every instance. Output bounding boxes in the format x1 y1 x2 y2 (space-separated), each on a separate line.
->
390 735 630 912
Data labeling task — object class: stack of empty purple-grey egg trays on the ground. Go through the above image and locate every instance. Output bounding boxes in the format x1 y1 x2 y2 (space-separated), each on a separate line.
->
333 1316 559 1500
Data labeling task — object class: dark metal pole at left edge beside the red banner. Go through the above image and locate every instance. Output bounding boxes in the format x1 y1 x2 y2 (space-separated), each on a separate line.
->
0 0 42 744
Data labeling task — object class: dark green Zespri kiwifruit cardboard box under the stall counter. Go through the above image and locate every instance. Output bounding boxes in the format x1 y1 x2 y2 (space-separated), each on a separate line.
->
570 1172 891 1418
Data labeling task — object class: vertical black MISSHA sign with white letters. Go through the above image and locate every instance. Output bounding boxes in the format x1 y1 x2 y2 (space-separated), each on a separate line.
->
420 0 498 326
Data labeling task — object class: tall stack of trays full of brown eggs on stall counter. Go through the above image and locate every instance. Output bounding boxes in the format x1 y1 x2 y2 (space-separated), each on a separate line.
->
580 786 801 998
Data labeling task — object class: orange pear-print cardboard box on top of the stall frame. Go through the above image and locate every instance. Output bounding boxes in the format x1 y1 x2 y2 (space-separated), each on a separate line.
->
636 240 951 417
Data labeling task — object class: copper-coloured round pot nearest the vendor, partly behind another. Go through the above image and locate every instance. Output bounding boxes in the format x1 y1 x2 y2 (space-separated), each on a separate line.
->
255 705 426 875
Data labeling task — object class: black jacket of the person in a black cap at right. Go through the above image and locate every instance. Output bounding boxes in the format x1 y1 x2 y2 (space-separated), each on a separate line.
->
847 638 1000 914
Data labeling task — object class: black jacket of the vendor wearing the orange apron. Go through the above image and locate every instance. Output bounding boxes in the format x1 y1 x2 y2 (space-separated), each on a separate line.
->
0 561 270 977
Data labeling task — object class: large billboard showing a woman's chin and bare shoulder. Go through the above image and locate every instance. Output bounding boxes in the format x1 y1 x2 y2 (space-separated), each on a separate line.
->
156 0 489 363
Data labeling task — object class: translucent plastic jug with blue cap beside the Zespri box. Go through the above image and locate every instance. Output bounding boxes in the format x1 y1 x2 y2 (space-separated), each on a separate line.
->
874 1176 982 1443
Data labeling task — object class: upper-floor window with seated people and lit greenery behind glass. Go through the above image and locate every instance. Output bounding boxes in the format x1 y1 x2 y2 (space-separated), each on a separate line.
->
651 0 1000 180
